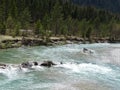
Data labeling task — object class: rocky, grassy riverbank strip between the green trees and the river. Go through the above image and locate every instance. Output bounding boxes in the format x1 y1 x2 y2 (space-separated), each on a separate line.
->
0 35 120 49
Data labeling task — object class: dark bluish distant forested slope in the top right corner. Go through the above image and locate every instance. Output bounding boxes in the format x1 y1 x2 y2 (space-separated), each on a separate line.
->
72 0 120 13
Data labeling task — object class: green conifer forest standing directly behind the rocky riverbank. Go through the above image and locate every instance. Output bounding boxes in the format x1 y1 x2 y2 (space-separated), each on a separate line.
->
0 0 120 39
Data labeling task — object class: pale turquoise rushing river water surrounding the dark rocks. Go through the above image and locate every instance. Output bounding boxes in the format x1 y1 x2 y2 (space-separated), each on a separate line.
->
0 43 120 90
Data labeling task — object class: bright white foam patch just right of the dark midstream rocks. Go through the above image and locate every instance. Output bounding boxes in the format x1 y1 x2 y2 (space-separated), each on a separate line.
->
56 63 112 74
